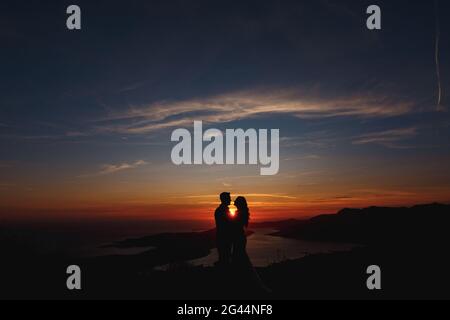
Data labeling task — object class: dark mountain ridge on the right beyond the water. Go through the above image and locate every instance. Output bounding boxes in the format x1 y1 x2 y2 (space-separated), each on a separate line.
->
273 203 450 245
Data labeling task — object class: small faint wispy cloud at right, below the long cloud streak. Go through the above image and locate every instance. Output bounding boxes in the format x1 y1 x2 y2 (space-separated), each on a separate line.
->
353 127 417 147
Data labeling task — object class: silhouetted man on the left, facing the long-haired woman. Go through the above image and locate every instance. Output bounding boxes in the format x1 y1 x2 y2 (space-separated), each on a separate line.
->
214 192 232 266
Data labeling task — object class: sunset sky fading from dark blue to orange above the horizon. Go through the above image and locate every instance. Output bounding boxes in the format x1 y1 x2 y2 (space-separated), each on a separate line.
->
0 0 450 220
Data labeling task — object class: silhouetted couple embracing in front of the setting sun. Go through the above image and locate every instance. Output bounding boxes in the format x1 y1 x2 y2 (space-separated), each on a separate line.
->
215 192 250 266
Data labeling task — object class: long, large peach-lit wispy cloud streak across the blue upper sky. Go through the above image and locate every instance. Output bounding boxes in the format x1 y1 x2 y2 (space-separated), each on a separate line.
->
96 90 414 134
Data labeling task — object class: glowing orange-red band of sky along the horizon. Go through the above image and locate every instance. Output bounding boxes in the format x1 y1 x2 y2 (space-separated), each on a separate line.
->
0 187 450 222
